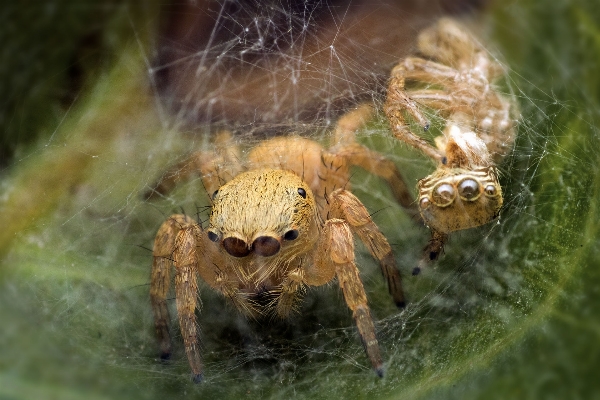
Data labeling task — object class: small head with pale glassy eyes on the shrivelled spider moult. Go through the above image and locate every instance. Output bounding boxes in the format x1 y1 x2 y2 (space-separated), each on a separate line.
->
418 167 502 233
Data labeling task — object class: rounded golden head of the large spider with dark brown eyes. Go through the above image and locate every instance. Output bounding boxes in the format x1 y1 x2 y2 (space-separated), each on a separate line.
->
206 169 318 258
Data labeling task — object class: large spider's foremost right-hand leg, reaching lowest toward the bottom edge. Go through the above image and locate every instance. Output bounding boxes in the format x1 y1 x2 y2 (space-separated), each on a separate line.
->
315 219 383 377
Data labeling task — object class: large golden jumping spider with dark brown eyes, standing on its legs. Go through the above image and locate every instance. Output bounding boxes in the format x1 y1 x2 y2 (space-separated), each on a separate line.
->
146 106 418 382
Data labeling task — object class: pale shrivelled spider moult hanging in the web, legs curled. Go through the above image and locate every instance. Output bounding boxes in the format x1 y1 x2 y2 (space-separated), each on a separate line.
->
384 18 516 275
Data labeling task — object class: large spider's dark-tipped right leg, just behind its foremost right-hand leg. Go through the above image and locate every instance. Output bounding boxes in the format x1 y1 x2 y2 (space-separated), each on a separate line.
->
329 189 406 307
